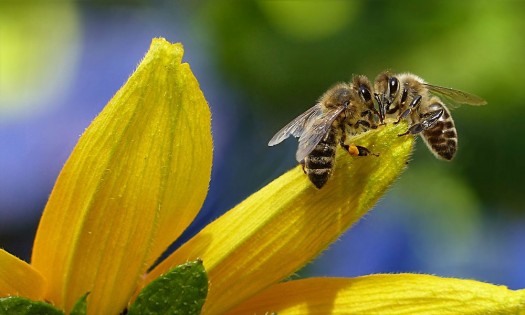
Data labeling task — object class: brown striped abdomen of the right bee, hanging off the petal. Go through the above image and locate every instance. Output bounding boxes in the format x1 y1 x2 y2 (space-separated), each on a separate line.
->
422 103 458 160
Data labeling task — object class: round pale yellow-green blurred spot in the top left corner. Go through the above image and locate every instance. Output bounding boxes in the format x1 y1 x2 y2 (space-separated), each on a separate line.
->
0 1 80 122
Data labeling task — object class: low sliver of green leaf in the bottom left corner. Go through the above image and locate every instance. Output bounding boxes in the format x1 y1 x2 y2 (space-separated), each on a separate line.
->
0 296 64 315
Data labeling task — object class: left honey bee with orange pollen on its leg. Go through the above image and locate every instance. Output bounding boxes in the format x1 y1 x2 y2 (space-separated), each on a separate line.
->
268 76 379 189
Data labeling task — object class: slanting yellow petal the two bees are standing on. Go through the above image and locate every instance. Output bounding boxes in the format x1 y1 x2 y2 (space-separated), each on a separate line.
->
146 124 413 314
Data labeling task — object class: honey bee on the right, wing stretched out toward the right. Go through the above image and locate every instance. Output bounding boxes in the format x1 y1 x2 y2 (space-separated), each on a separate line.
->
374 71 487 160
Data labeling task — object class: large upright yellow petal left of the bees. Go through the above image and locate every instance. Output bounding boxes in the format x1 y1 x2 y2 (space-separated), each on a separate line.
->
32 39 212 314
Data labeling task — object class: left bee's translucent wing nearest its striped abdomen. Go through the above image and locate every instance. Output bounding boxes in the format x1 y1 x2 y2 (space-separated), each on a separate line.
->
295 106 345 162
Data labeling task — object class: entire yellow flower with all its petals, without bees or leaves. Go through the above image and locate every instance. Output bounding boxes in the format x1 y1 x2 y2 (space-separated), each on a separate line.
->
0 39 525 314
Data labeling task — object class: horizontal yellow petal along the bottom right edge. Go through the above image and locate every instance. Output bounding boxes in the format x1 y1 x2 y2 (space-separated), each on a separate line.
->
228 274 525 315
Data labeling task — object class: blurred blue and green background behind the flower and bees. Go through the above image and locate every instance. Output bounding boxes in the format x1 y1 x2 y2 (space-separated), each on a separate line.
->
0 0 525 289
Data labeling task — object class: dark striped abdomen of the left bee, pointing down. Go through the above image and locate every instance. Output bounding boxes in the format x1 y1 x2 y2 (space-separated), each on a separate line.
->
304 130 336 189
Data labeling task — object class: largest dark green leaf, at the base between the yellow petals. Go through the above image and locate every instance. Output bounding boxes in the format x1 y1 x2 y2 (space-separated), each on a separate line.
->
128 260 208 315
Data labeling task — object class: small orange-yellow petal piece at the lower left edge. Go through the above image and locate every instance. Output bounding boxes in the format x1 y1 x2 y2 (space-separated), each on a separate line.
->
0 249 46 300
